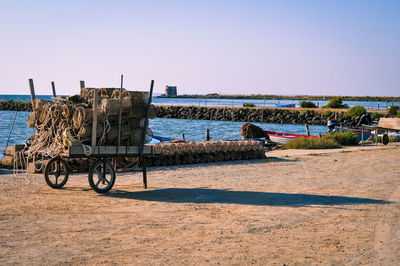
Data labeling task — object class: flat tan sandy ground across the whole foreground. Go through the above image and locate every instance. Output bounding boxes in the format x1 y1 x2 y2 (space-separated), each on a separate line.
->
0 143 400 265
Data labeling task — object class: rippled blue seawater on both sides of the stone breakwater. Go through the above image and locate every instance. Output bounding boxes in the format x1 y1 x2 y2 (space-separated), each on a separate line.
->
0 95 400 158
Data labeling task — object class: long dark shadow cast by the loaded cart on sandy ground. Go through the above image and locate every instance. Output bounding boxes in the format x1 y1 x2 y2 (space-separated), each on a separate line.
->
101 188 391 207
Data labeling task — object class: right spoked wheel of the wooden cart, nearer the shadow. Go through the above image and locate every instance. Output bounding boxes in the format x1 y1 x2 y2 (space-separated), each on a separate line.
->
89 160 115 193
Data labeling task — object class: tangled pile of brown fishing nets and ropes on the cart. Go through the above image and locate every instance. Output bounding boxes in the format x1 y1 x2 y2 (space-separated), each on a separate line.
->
23 88 155 172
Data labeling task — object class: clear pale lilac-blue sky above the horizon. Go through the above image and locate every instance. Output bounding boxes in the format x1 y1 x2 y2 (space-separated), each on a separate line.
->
0 0 400 96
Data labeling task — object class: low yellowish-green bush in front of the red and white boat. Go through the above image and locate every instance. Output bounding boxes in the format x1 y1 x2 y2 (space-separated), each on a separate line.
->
283 137 340 149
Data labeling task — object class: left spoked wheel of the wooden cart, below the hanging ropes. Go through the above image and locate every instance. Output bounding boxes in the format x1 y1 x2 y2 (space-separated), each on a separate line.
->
44 157 69 188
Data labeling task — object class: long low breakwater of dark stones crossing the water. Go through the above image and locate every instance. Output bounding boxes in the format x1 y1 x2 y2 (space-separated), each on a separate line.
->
0 101 366 127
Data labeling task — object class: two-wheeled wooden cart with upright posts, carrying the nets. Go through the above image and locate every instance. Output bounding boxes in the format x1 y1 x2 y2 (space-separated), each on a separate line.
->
44 80 154 193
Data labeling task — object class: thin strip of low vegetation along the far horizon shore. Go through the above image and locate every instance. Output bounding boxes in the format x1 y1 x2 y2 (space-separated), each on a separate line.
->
155 93 400 102
